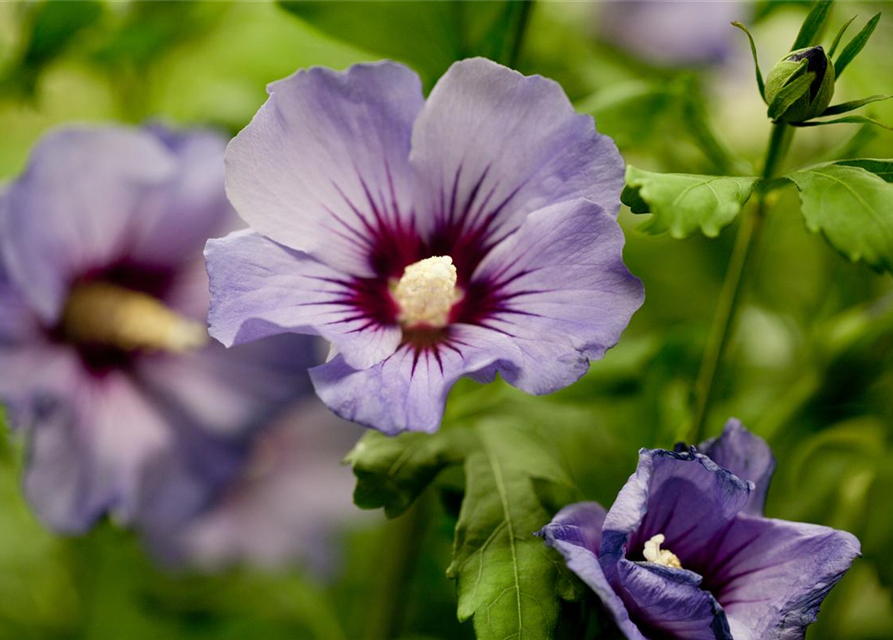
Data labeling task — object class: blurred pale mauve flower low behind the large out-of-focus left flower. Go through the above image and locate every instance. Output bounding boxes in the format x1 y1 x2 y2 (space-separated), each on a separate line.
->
147 395 370 577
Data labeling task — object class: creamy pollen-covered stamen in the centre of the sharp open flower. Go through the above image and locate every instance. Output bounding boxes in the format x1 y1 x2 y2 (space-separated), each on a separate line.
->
392 256 461 327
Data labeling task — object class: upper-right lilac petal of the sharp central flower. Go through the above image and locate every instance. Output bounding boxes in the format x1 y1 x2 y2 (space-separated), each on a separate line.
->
410 58 624 244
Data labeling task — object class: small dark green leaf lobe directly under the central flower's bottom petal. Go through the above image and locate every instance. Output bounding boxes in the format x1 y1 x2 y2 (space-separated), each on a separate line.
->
345 429 470 518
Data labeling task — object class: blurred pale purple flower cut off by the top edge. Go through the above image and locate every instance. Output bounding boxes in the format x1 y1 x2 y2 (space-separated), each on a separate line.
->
597 0 753 67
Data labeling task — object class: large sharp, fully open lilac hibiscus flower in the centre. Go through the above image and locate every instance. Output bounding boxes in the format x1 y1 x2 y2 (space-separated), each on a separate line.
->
206 59 643 433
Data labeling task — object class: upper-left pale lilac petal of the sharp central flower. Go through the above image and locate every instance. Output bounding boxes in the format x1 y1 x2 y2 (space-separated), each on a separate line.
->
226 62 424 276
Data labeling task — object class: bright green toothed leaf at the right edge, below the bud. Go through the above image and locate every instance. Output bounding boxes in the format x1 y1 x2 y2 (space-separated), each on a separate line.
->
786 160 893 271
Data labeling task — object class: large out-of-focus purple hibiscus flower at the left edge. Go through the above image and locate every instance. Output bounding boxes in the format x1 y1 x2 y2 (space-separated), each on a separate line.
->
0 127 312 532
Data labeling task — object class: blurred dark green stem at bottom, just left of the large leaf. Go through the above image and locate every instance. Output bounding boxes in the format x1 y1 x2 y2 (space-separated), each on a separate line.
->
363 496 428 640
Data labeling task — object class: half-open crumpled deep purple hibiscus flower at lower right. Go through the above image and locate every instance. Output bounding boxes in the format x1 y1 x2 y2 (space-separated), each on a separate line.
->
538 420 859 640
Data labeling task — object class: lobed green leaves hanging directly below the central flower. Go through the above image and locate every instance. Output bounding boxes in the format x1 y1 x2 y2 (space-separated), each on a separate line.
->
347 418 581 640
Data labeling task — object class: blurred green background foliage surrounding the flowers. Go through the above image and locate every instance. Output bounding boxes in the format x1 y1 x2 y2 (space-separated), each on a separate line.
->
0 0 893 640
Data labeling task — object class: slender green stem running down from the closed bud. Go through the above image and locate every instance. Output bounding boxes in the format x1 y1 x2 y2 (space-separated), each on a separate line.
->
688 123 793 444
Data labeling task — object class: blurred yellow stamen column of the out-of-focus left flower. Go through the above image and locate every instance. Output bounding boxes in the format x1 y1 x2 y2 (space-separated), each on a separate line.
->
61 282 208 352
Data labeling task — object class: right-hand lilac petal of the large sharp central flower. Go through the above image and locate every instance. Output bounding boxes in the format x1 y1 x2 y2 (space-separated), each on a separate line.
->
472 199 644 395
